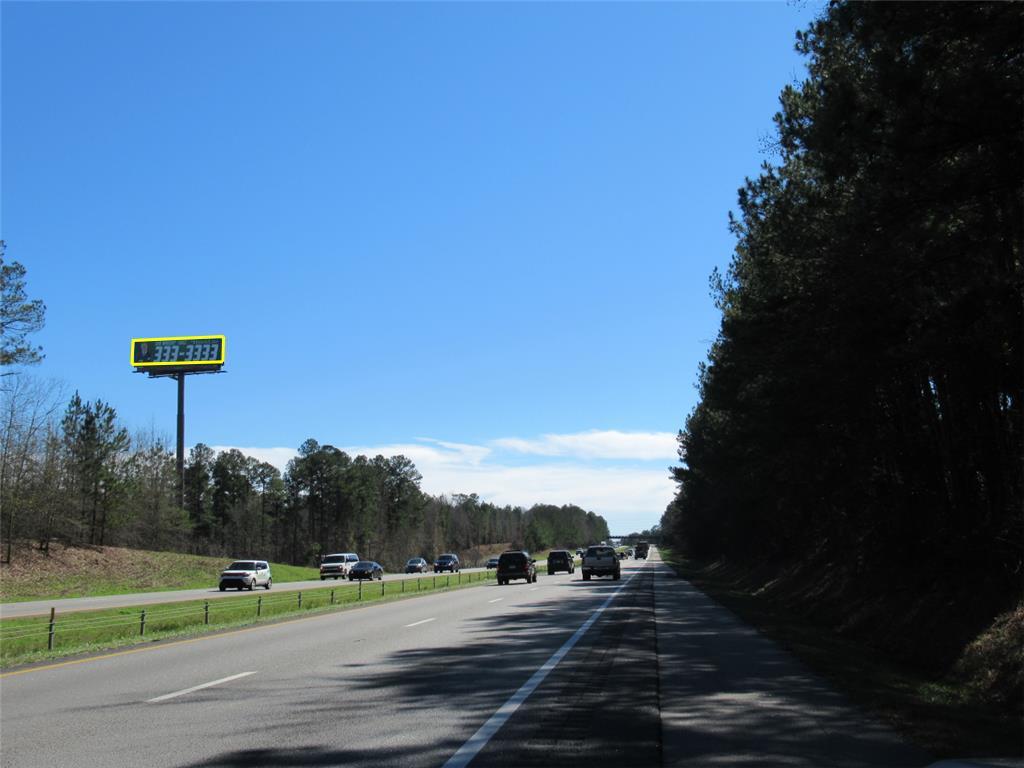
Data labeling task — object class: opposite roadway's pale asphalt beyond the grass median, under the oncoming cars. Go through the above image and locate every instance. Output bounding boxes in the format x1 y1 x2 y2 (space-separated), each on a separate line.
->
0 568 486 618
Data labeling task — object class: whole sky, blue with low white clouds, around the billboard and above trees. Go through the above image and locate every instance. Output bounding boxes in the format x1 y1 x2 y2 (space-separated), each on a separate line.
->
0 2 818 529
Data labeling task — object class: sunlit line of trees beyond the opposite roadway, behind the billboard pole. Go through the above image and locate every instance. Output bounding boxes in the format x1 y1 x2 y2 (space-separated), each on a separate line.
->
0 374 608 569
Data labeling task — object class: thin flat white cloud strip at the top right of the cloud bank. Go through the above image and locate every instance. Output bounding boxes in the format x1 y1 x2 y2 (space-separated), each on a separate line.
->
494 429 677 462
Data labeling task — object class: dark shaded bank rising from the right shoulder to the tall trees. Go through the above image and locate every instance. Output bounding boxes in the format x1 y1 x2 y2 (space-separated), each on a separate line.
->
662 549 1024 757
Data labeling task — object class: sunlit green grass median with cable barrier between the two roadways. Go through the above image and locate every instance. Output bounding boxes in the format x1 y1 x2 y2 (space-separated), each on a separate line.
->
0 570 495 669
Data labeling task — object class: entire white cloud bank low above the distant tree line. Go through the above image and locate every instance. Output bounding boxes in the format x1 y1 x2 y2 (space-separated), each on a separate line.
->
203 431 676 534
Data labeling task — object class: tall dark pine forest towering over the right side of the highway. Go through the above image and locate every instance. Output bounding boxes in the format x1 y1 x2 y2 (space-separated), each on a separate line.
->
663 2 1024 704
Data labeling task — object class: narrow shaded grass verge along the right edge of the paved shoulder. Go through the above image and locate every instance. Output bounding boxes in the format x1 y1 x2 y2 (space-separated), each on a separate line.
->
658 547 1024 759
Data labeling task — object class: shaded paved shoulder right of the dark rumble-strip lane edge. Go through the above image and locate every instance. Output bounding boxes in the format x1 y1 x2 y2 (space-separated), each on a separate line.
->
651 561 931 768
